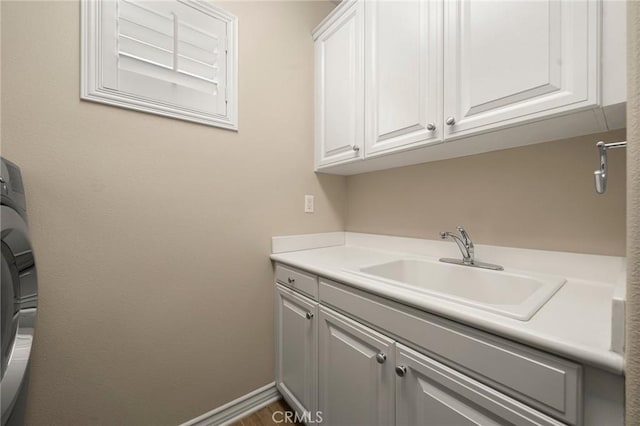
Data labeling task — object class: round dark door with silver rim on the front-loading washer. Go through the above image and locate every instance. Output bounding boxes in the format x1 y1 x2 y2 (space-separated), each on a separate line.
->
0 206 38 424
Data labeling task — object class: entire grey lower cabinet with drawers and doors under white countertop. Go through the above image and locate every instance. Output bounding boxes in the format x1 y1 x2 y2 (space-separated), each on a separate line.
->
275 265 624 426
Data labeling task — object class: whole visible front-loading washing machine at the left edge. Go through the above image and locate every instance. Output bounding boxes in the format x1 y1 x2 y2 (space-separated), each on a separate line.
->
0 158 38 426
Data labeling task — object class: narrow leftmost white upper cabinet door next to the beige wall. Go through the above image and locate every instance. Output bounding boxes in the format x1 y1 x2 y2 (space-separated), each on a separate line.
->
315 1 364 169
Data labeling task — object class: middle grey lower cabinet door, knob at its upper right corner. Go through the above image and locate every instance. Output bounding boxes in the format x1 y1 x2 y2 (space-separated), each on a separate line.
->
318 306 395 426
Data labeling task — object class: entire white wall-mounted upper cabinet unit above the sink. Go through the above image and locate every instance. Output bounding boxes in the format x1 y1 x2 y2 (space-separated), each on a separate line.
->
314 0 626 174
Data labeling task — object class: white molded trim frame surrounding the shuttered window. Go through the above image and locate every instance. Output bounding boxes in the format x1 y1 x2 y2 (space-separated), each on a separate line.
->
80 0 238 130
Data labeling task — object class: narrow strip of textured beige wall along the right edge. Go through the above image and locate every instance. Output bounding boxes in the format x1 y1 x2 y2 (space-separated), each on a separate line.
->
626 1 640 426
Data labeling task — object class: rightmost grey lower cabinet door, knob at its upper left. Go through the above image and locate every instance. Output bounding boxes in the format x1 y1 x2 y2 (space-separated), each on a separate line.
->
395 343 563 426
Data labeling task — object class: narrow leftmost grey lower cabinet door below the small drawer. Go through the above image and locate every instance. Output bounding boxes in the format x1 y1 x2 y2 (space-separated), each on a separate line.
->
275 284 318 421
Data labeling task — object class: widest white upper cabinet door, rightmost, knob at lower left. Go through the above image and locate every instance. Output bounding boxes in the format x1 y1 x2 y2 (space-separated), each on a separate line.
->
444 0 600 138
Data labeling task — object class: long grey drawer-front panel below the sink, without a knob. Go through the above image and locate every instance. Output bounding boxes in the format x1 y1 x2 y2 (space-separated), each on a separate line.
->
319 279 582 425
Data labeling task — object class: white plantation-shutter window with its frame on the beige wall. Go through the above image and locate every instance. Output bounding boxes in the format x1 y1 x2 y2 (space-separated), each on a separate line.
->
83 0 237 128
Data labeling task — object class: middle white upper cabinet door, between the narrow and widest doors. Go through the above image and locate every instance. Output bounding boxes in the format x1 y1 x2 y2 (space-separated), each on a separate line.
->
365 0 443 156
